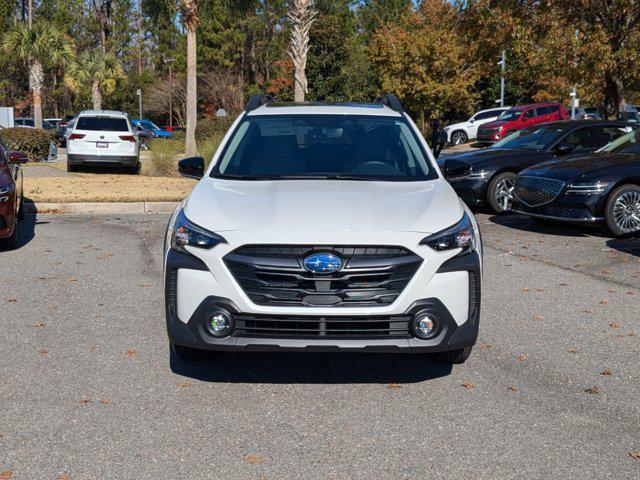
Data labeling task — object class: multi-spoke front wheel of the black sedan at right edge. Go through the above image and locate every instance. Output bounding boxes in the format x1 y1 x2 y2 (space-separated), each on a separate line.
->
604 184 640 237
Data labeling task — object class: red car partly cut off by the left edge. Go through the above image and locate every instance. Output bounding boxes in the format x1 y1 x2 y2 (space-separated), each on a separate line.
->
0 143 28 249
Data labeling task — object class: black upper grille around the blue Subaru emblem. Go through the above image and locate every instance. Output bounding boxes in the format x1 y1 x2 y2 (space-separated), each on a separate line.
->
224 245 422 307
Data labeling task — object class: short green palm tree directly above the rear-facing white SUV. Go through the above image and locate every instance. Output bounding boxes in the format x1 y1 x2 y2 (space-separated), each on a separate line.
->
64 48 124 110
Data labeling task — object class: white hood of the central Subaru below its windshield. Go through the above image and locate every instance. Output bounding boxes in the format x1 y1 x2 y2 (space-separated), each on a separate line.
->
185 178 463 233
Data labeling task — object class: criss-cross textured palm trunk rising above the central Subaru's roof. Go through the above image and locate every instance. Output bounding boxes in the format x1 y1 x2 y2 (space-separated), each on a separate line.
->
287 0 316 102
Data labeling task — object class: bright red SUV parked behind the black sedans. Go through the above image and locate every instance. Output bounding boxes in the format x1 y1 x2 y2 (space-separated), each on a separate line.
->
478 103 569 143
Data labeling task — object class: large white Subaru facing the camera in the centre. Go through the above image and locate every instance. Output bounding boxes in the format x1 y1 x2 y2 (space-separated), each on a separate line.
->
164 95 482 363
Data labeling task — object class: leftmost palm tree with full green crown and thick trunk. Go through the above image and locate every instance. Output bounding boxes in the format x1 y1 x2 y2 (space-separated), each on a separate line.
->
2 20 75 128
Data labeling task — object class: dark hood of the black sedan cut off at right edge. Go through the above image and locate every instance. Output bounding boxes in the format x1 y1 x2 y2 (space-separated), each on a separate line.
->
520 152 640 182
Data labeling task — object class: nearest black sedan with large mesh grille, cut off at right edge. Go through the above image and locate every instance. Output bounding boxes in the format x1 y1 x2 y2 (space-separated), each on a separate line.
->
513 130 640 236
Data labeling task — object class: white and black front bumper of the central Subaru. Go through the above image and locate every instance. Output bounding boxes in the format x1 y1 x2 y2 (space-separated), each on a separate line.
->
165 250 481 352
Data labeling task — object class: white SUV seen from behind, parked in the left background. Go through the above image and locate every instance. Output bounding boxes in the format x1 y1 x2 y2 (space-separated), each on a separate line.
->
67 110 140 173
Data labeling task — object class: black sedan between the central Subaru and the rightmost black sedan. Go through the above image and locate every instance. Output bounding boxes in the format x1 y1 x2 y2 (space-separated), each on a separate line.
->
440 120 634 213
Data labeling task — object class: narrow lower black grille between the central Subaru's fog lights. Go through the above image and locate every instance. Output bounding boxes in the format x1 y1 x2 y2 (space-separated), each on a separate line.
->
235 313 411 339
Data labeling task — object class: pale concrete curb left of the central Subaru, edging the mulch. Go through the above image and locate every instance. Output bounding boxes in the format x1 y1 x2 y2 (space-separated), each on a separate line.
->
24 202 180 214
